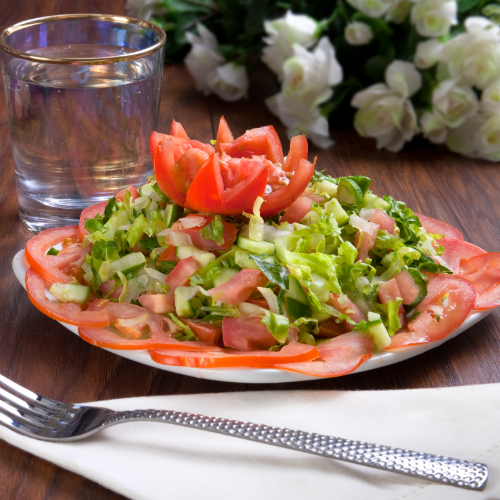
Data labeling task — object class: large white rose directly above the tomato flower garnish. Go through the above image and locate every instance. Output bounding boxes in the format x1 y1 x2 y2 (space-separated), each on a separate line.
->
266 37 342 147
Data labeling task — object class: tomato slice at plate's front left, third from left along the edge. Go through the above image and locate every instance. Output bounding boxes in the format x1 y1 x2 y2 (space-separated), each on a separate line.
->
78 300 220 351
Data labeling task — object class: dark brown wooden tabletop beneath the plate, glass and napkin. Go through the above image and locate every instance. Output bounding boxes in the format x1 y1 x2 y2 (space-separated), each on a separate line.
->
0 0 500 500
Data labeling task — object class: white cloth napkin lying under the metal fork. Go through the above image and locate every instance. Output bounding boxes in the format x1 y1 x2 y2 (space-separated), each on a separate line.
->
0 384 500 500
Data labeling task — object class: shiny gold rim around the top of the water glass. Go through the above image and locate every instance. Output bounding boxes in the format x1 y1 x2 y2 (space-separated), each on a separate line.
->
0 14 167 65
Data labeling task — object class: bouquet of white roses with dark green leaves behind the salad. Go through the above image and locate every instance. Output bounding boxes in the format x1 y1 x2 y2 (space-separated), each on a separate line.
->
127 0 500 161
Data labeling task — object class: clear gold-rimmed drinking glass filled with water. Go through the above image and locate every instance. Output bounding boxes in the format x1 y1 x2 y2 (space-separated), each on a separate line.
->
0 14 165 233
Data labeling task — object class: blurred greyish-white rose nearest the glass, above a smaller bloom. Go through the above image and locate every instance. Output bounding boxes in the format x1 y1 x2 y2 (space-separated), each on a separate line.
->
184 24 225 95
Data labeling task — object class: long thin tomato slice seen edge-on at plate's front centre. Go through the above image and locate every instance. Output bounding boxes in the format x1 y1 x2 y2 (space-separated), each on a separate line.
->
149 342 319 368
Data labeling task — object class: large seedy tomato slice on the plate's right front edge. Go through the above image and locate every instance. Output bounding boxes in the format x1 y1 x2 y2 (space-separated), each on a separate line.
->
387 274 477 350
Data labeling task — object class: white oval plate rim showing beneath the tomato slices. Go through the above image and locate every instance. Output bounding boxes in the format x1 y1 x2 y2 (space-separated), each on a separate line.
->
12 250 492 384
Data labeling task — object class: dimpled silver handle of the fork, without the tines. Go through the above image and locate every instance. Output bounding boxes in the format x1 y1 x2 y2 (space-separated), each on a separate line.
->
103 410 488 490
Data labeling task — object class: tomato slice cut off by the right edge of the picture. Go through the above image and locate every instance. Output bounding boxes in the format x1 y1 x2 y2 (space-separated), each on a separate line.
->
460 252 500 310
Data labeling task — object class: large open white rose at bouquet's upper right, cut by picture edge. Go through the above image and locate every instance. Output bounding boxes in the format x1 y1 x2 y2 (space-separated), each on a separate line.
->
442 17 500 90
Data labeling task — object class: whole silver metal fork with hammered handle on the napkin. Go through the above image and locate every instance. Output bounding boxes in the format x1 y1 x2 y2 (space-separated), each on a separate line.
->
0 375 488 490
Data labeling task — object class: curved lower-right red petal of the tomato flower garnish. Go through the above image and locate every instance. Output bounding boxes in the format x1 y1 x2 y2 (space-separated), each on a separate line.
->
260 159 316 217
